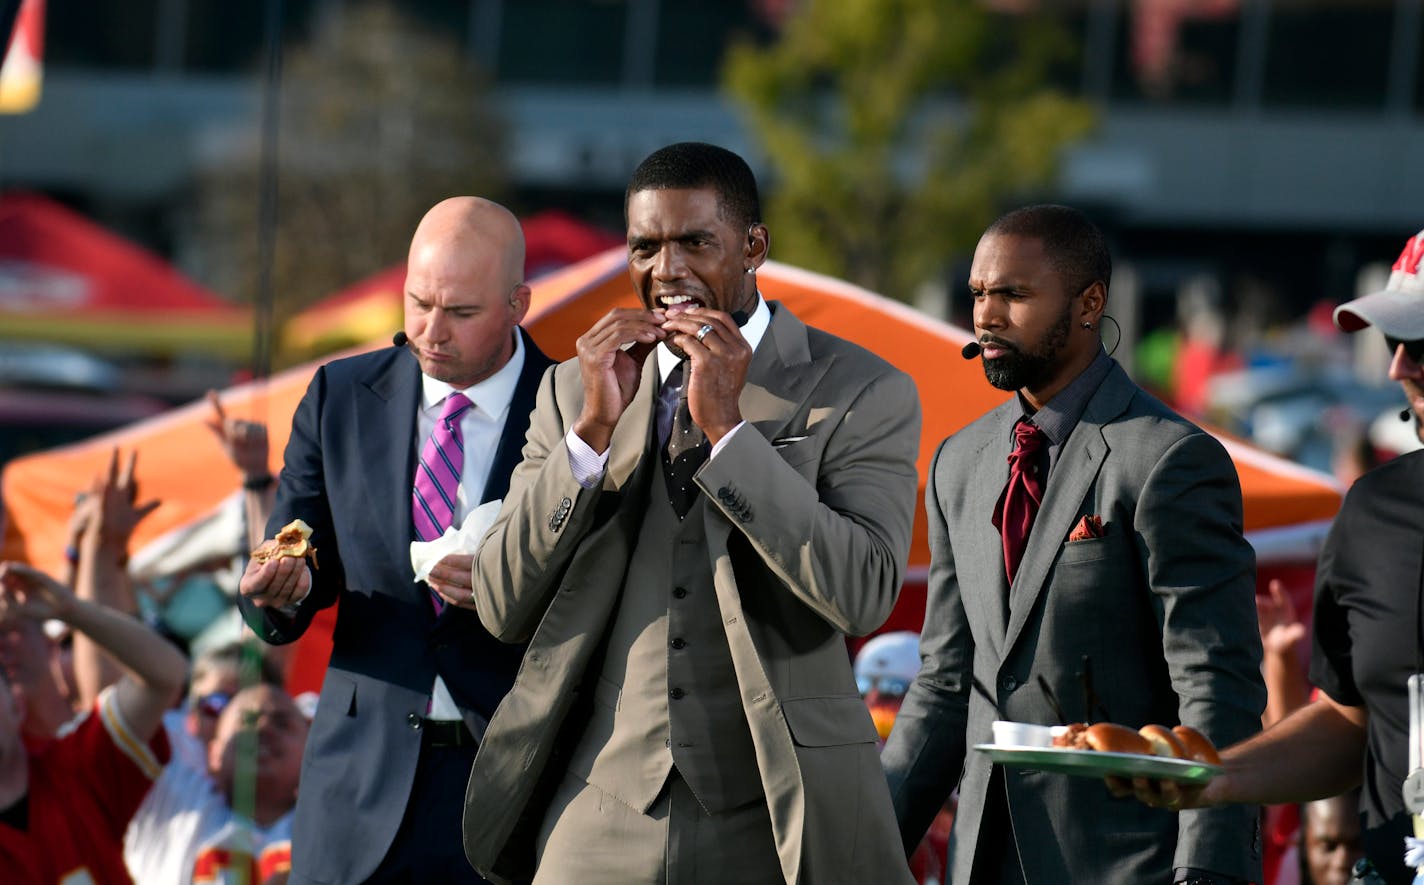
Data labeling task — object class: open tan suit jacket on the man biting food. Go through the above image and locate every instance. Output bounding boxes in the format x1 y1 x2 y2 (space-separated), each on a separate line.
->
464 305 920 885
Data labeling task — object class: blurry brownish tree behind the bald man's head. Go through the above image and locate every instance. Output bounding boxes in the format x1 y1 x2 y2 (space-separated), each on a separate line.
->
183 3 507 354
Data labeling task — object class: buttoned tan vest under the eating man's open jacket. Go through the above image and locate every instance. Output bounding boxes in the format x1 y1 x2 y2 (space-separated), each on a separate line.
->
570 469 762 812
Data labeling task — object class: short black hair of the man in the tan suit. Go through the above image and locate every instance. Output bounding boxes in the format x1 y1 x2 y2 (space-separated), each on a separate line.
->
624 141 762 228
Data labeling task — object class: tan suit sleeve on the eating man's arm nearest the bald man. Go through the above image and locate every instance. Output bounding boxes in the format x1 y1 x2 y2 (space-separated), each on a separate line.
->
474 360 601 643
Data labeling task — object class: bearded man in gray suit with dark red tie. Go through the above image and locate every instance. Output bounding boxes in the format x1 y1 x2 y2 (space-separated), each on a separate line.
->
881 205 1266 885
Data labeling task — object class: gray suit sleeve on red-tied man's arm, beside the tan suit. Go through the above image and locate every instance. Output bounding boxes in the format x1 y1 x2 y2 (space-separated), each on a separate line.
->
880 442 974 855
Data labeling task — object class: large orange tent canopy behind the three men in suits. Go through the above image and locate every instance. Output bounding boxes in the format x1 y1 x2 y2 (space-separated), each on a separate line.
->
0 248 1340 578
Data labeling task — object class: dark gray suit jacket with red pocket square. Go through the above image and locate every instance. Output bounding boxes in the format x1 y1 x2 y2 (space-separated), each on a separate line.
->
881 365 1266 885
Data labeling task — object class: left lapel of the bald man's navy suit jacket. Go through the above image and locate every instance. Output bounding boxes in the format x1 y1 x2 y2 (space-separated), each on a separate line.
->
355 351 420 584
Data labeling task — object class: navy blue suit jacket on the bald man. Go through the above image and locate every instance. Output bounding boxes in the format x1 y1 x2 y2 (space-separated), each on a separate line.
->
239 329 551 882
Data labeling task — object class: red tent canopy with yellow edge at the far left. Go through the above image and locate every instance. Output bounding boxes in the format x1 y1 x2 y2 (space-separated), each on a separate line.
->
0 192 251 355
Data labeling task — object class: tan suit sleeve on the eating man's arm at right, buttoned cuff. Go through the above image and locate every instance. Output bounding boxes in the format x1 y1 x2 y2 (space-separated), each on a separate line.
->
696 371 920 634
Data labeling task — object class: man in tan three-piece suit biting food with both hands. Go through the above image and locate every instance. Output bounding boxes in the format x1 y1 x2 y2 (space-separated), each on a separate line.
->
464 144 920 885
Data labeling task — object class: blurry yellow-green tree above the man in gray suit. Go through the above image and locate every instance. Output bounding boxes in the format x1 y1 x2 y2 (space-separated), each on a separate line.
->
722 0 1094 298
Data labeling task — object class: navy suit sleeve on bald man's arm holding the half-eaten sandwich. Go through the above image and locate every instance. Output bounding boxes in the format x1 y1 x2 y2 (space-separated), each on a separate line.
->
238 366 346 646
